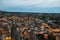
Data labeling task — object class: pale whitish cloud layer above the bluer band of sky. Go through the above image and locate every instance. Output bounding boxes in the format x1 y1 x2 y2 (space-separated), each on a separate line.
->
1 0 60 7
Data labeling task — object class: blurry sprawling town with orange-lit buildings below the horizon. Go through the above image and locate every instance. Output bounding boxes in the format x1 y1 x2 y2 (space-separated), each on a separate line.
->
0 11 60 40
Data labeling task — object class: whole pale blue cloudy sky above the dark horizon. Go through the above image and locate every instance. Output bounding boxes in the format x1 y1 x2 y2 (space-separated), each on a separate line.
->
0 0 60 13
